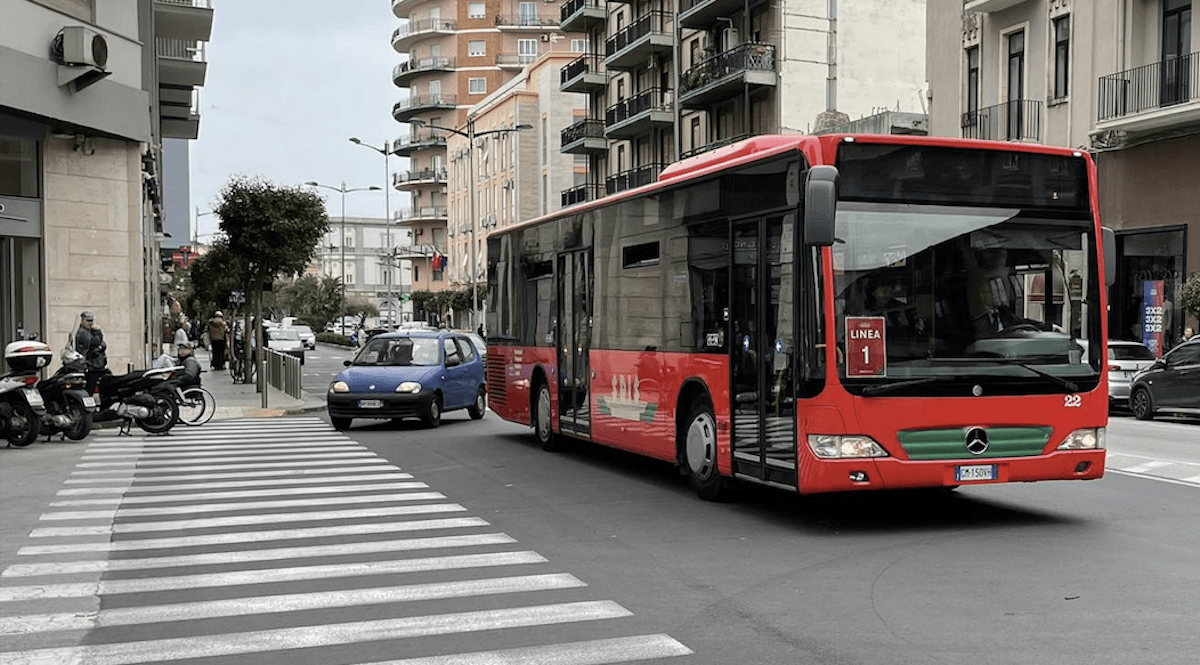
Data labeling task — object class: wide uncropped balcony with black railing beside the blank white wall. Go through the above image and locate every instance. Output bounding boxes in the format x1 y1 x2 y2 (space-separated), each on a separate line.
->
679 43 779 108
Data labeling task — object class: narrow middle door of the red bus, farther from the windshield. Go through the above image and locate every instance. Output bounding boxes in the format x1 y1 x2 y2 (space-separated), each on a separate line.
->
557 251 592 435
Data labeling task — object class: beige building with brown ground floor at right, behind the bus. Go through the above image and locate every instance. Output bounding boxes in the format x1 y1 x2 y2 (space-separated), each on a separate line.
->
926 0 1200 348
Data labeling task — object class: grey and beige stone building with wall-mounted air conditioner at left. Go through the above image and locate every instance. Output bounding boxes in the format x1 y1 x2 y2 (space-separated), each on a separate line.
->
0 0 212 369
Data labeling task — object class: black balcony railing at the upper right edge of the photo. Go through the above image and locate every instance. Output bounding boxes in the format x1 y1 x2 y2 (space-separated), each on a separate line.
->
1097 53 1200 120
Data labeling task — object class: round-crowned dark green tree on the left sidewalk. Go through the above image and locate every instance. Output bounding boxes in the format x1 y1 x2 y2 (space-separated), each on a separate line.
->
212 175 329 390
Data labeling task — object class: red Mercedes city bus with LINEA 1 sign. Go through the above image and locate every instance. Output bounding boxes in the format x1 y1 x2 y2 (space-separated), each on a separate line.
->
486 136 1112 499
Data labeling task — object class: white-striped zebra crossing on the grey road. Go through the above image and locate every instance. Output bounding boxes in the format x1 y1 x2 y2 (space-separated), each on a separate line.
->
0 418 692 665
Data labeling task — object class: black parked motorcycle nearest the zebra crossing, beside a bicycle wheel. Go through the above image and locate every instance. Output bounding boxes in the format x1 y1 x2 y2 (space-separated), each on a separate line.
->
65 358 179 435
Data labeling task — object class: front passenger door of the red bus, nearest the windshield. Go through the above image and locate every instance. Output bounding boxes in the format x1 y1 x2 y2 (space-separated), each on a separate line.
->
730 215 798 489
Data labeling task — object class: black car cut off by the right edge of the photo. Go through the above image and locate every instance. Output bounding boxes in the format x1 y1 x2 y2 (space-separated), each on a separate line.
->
1129 340 1200 420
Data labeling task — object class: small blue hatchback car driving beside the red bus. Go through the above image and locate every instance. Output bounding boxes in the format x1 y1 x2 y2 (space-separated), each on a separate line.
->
325 330 487 430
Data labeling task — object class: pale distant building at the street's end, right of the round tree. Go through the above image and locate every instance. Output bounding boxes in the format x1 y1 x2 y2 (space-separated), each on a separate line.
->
308 217 412 323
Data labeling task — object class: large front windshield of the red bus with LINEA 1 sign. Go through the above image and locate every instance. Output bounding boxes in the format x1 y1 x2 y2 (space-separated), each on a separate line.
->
833 202 1103 396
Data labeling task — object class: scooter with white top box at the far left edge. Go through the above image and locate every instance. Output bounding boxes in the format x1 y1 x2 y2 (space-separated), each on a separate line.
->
0 340 53 448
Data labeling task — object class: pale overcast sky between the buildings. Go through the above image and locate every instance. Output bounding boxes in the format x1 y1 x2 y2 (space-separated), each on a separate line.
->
190 0 406 242
